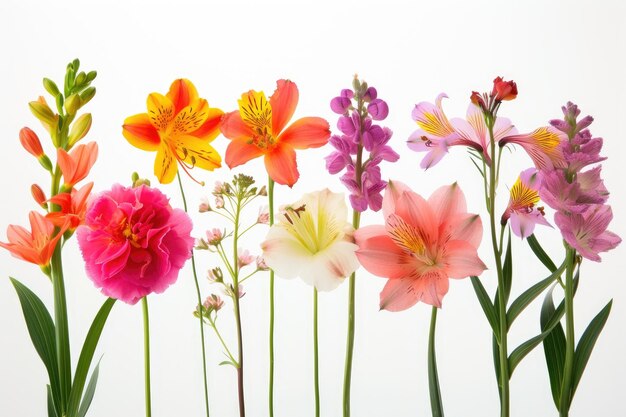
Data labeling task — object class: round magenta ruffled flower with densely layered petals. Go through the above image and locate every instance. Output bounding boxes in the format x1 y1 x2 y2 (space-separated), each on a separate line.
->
77 184 194 304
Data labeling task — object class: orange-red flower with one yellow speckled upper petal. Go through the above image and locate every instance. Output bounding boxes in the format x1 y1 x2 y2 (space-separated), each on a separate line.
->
220 80 330 187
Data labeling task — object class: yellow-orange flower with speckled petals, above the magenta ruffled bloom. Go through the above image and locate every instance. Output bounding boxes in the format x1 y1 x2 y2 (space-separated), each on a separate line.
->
122 79 224 184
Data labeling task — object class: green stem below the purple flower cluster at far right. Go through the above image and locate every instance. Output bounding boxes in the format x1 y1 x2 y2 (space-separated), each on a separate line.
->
559 247 576 417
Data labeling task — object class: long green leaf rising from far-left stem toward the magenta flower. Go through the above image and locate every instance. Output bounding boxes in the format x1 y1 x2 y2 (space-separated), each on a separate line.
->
68 298 115 417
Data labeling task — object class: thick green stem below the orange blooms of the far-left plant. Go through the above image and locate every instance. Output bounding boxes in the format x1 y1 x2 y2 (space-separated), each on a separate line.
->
51 244 72 415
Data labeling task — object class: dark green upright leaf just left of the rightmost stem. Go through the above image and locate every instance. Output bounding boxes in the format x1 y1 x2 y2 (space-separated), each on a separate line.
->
539 284 565 409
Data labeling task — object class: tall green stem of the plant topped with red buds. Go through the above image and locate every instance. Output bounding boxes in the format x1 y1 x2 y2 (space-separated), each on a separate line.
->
487 119 510 417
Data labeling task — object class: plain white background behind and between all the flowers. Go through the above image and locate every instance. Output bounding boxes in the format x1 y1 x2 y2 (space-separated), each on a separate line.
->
0 0 626 417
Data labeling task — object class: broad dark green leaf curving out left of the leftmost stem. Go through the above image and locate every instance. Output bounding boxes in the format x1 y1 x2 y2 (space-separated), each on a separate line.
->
10 278 60 415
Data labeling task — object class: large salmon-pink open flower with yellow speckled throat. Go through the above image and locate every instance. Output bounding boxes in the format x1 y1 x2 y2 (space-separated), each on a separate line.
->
355 181 486 311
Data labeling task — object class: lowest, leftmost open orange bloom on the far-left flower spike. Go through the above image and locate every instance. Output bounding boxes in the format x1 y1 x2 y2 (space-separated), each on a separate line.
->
0 211 68 268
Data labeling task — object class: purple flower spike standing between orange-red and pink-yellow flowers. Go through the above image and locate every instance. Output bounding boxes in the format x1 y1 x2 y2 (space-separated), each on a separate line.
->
326 77 400 212
